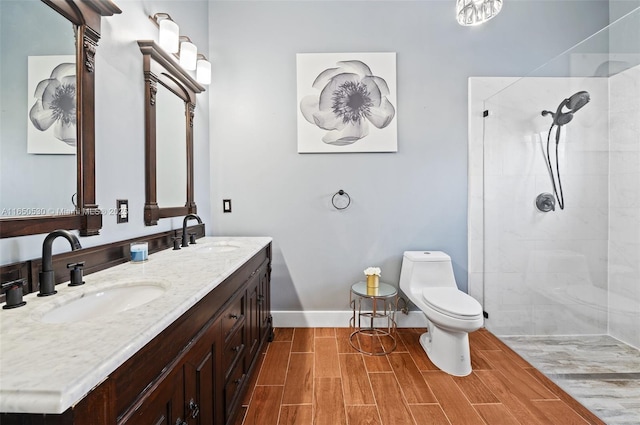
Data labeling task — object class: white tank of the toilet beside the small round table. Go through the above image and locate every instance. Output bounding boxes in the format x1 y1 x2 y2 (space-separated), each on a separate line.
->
400 251 457 290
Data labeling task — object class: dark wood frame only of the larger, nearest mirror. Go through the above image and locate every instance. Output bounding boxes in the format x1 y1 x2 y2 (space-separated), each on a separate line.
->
0 0 122 238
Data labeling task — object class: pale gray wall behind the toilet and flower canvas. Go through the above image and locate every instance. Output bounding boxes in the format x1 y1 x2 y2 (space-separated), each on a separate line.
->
209 0 609 310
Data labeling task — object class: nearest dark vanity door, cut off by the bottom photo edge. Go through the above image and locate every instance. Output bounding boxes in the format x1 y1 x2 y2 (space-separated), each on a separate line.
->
119 367 188 425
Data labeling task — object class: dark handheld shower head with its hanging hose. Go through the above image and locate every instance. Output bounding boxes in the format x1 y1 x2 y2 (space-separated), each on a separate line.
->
542 90 591 210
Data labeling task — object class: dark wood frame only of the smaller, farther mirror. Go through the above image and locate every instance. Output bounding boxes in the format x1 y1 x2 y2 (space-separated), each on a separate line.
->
138 40 205 226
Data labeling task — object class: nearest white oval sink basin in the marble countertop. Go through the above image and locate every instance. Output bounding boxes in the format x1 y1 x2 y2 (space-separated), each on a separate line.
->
38 282 169 323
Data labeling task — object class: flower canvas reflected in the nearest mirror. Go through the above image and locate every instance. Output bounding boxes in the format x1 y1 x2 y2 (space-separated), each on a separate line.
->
26 55 76 155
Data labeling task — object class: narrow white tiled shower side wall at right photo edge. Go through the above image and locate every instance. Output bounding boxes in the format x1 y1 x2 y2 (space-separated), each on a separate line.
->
609 66 640 348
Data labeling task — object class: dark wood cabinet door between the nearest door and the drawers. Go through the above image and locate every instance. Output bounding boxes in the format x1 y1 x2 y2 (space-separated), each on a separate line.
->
184 320 224 425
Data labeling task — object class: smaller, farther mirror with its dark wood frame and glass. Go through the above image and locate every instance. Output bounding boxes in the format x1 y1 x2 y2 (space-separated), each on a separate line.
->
138 40 205 226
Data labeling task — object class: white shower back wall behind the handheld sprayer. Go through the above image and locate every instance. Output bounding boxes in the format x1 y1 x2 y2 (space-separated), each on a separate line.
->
469 78 609 335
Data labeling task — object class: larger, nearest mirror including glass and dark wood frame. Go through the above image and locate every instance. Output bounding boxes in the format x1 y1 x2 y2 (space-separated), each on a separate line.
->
0 0 121 238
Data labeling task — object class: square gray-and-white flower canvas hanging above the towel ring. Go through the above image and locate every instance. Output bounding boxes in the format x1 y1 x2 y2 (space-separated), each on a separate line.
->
296 53 398 153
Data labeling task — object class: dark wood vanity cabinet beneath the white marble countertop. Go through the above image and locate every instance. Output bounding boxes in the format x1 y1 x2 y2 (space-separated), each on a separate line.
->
0 245 272 425
